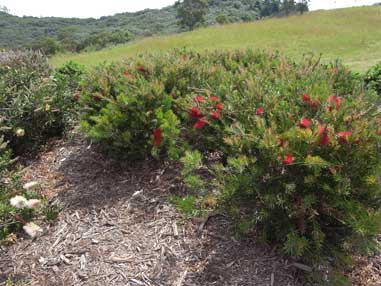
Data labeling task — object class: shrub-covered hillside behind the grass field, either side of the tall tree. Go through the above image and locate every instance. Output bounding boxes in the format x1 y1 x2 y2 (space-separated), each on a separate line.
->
0 0 308 54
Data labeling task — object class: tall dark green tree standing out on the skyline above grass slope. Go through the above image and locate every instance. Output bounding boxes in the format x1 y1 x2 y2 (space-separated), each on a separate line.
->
175 0 209 30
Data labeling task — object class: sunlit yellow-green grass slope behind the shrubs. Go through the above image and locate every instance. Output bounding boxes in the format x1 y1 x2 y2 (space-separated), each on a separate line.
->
51 6 381 71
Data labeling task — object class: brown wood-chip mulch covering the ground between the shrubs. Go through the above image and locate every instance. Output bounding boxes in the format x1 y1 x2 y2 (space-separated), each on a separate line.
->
0 135 381 286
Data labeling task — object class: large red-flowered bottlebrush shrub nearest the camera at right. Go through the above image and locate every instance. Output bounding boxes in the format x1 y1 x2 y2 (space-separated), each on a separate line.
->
208 60 381 268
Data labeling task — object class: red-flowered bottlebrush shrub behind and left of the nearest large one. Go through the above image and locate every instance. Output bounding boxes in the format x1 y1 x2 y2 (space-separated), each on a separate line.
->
80 51 265 158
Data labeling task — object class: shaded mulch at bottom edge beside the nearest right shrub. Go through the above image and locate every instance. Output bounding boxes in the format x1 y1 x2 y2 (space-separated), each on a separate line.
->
186 216 301 286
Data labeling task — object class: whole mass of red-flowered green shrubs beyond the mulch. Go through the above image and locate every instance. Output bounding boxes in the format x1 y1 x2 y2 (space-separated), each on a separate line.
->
81 51 381 282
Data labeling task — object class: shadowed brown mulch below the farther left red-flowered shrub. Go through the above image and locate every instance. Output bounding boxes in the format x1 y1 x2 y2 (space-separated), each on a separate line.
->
58 141 184 209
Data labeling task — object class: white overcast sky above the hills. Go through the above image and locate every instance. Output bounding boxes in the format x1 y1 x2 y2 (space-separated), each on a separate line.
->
0 0 381 18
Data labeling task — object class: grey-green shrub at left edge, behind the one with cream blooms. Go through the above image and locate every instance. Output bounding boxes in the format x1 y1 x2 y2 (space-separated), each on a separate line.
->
0 51 75 153
